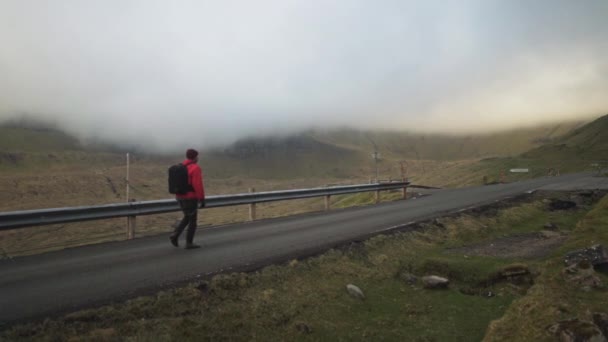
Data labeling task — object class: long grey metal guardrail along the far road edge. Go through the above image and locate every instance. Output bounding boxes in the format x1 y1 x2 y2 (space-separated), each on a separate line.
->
0 182 409 230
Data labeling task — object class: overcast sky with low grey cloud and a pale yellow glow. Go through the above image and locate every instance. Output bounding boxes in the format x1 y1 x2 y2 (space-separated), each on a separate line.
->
0 0 608 149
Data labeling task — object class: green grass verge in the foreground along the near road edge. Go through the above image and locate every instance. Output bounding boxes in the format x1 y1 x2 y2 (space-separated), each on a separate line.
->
0 191 608 341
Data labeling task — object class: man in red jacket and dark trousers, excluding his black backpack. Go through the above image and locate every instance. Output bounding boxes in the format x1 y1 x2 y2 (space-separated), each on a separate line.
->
169 149 205 249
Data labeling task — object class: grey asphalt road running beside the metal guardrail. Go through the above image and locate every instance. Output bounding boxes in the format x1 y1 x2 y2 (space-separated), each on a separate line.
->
0 174 608 325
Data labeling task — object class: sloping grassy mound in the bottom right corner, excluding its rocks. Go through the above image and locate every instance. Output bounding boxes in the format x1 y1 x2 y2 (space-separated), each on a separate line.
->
484 196 608 341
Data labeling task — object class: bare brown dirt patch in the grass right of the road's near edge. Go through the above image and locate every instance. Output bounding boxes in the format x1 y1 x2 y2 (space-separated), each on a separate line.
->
446 231 566 259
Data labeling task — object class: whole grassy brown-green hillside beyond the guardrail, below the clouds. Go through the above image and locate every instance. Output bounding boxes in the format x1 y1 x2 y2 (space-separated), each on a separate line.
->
0 118 608 210
